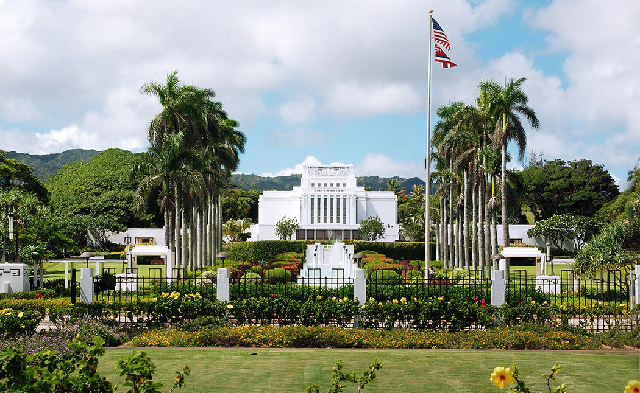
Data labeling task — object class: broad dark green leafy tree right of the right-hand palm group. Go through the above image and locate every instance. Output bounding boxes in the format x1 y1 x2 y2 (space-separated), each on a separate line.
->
522 159 619 219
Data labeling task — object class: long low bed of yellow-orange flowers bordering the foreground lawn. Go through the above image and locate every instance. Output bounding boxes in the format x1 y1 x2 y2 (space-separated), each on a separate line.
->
129 326 600 350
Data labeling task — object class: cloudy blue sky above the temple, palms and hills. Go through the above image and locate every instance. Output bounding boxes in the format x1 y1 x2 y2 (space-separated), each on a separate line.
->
0 0 640 188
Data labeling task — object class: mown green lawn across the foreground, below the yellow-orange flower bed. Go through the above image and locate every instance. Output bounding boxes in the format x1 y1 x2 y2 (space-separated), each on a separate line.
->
99 348 640 393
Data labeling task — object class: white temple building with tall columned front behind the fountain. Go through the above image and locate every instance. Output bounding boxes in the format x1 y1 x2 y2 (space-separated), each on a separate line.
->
249 164 399 241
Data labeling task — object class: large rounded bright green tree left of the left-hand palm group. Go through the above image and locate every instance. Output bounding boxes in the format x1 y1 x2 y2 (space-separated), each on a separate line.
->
46 149 152 246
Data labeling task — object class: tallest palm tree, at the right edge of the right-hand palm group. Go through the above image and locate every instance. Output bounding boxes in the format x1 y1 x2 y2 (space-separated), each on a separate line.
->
480 78 540 256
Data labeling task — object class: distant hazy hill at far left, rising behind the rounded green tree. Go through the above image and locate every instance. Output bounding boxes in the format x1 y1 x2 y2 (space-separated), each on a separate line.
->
7 149 100 183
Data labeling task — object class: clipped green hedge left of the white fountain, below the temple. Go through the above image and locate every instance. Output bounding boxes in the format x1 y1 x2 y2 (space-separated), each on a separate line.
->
224 240 307 261
